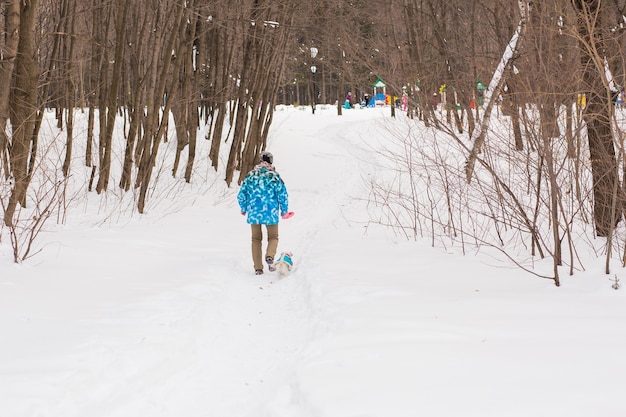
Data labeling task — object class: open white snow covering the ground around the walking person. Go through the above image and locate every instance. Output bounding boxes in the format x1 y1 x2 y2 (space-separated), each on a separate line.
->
0 108 626 417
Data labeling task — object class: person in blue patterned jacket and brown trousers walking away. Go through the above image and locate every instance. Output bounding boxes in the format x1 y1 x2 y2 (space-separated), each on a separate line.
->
237 151 293 275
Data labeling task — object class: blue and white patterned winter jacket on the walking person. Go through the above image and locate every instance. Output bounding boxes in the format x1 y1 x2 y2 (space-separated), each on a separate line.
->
237 162 289 224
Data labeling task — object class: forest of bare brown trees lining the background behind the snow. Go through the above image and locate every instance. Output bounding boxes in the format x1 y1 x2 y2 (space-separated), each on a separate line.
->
0 0 626 283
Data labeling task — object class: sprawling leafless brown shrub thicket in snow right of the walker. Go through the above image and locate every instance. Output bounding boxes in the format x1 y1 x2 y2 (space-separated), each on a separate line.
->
371 106 593 279
